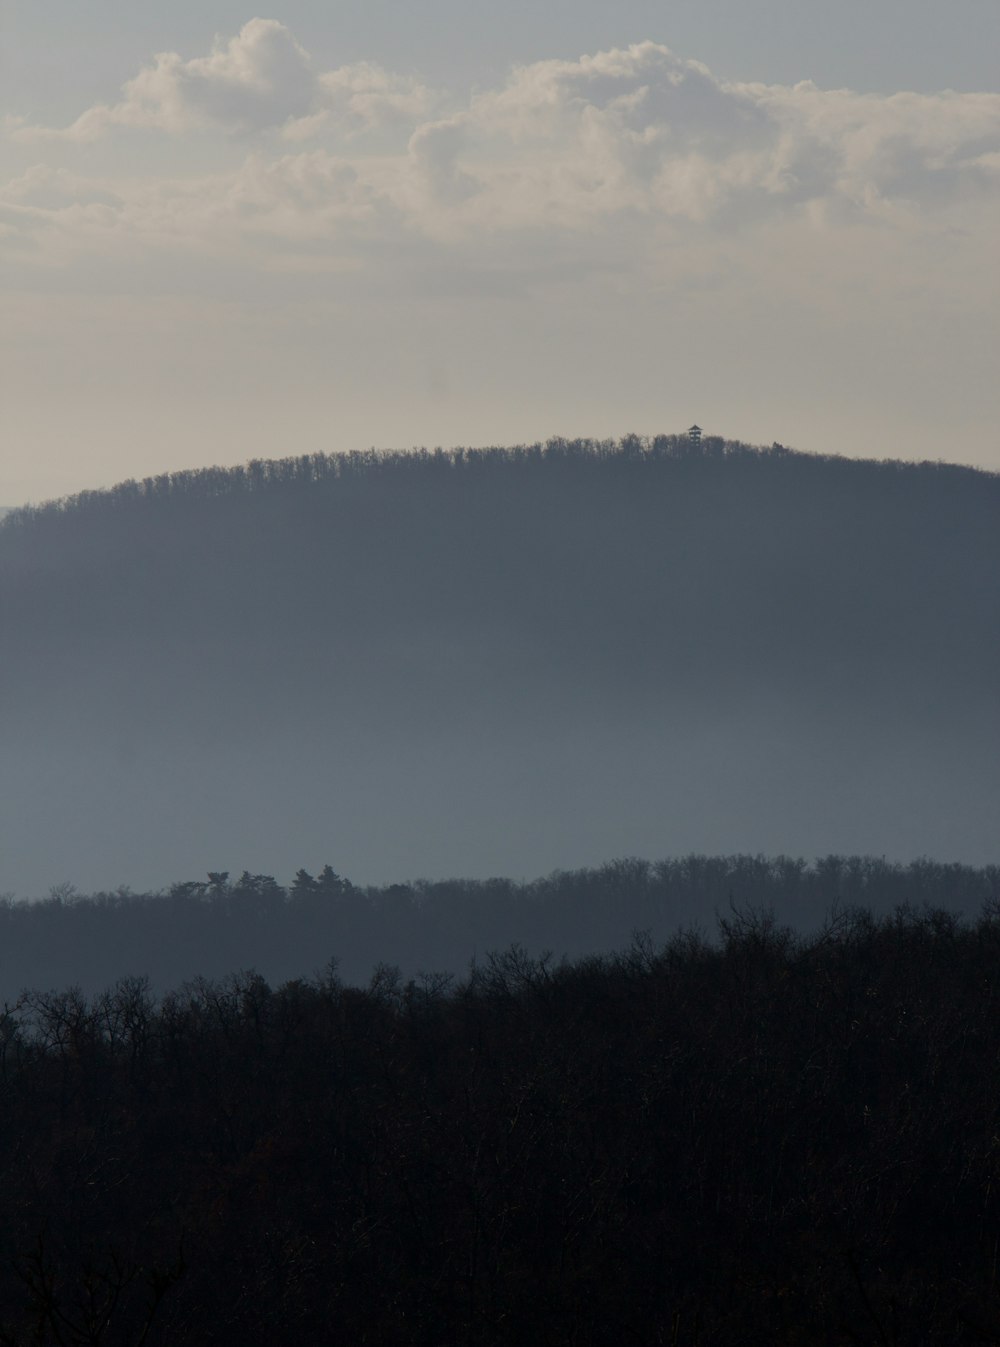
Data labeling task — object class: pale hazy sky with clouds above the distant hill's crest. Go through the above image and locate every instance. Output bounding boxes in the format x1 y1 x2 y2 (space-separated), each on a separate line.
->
0 0 1000 505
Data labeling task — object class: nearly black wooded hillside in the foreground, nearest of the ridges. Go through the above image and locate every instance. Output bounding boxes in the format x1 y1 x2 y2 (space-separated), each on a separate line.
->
0 909 1000 1347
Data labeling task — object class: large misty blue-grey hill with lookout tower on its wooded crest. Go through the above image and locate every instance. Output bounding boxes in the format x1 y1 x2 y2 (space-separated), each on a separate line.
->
0 436 1000 896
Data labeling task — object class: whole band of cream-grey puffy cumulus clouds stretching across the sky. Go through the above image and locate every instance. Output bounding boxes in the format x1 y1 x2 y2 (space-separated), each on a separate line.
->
0 28 1000 265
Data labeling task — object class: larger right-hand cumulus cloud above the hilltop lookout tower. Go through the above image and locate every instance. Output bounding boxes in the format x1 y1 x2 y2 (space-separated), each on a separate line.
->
444 42 1000 221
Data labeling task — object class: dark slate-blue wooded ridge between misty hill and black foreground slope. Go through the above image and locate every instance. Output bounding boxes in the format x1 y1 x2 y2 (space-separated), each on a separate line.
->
0 855 1000 999
